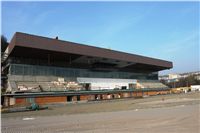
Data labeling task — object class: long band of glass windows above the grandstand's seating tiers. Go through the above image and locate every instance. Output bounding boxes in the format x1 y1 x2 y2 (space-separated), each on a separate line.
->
9 64 158 80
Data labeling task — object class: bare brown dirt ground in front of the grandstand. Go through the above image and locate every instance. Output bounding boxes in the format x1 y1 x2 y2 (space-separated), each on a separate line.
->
1 92 200 133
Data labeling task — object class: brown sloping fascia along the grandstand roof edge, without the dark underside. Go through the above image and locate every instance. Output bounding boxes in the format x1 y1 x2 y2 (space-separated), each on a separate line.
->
9 32 172 69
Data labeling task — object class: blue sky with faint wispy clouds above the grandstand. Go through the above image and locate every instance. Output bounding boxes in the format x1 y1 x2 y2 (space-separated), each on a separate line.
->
1 2 200 75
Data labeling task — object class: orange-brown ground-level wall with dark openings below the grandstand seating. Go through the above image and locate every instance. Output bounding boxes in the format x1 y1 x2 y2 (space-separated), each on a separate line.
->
4 90 170 106
